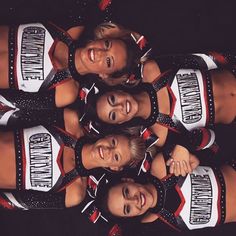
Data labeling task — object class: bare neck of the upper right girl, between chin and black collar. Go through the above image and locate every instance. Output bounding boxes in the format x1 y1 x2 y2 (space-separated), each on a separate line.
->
134 91 151 119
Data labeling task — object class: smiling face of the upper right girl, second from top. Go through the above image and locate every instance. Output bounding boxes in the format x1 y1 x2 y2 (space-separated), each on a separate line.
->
96 91 138 124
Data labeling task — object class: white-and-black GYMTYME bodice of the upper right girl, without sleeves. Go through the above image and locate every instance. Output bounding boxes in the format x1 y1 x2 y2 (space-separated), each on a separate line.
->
150 69 215 131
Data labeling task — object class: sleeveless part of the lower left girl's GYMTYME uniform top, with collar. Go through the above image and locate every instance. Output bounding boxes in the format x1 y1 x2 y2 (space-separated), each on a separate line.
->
15 126 89 192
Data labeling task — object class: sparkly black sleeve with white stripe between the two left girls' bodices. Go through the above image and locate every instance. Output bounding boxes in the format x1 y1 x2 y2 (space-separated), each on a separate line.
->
0 89 63 128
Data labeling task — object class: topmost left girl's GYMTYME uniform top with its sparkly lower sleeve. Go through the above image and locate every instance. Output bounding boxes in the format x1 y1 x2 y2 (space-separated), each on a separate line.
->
0 23 87 128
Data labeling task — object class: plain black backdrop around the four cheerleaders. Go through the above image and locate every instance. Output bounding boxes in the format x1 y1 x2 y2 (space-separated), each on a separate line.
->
0 0 236 236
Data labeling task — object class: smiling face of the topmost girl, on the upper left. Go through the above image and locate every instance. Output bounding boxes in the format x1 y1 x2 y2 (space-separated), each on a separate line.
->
80 39 127 79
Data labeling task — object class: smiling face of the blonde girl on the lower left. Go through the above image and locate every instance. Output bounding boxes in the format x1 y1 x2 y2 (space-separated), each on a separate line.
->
91 135 131 171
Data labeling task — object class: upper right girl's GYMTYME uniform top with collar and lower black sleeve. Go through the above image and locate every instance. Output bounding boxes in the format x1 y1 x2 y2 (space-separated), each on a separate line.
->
136 73 215 150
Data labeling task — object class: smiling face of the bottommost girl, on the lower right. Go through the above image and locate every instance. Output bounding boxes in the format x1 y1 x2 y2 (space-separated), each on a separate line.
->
107 179 156 217
